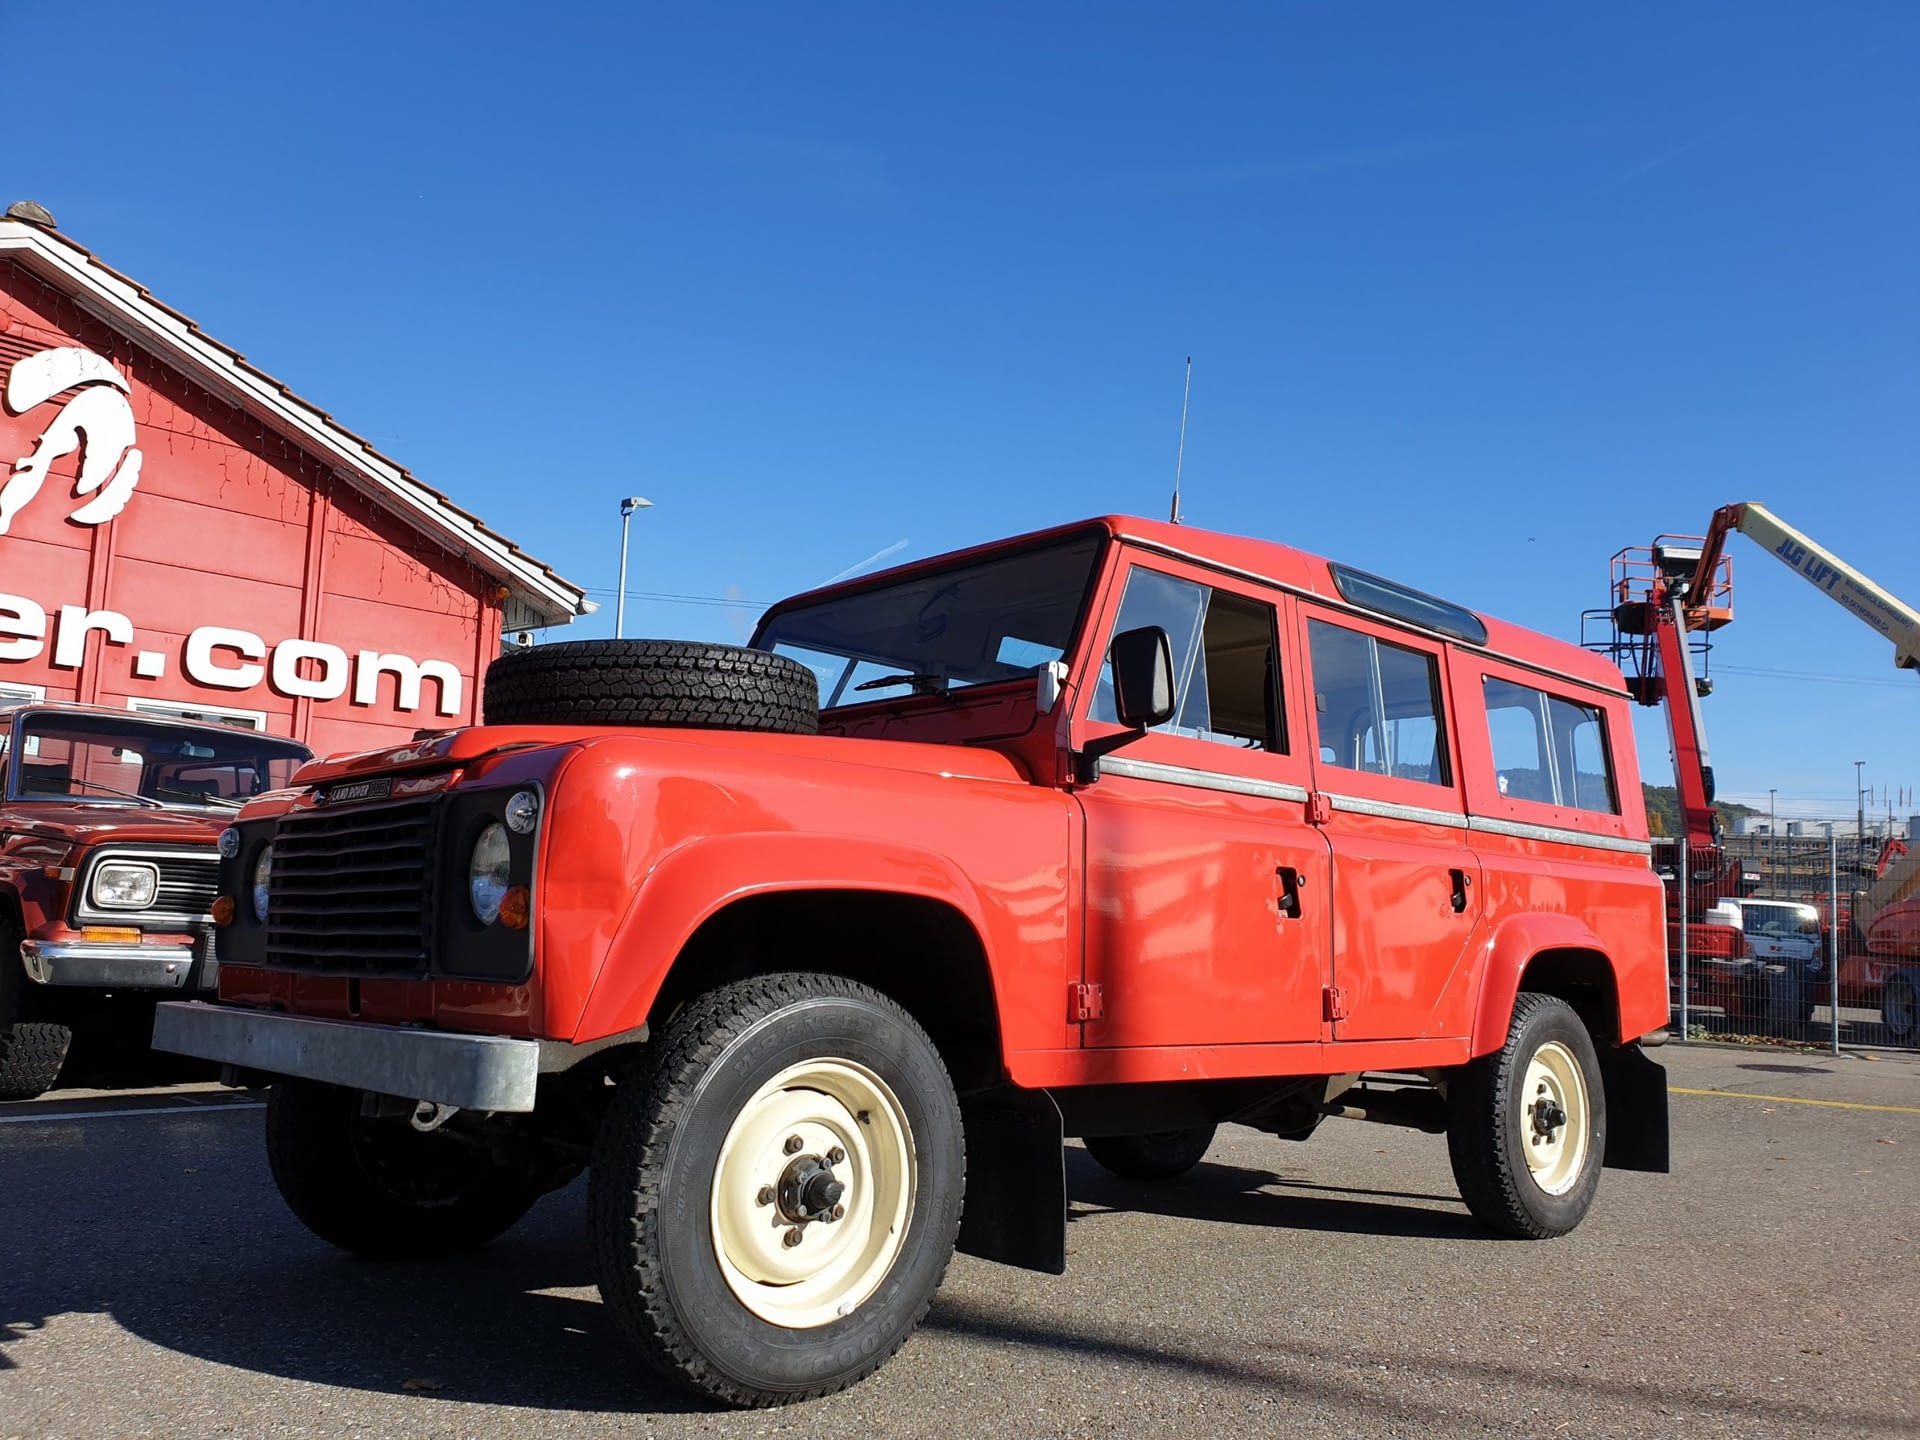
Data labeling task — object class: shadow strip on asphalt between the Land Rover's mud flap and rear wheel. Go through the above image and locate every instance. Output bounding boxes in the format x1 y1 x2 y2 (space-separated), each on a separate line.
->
1068 1146 1474 1240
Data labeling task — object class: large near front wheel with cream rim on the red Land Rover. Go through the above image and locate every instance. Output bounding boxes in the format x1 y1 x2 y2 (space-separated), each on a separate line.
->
588 973 966 1405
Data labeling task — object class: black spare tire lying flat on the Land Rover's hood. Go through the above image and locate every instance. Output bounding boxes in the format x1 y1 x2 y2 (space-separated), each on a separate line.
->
484 639 820 735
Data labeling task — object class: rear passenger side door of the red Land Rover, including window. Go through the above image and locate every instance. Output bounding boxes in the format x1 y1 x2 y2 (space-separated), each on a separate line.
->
1300 603 1484 1041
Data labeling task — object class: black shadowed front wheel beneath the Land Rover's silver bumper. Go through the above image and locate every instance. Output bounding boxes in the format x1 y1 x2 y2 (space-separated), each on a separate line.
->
267 1079 543 1260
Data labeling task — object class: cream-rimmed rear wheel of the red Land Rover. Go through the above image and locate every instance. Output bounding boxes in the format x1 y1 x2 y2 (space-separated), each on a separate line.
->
1448 993 1607 1240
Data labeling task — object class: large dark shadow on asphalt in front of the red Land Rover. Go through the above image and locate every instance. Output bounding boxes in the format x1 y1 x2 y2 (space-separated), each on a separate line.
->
0 1187 710 1413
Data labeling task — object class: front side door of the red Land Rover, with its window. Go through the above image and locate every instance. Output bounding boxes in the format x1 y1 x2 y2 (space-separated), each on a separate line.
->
1073 559 1332 1046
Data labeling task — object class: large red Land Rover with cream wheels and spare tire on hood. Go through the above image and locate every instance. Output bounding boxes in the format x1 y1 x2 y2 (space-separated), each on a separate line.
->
156 518 1667 1405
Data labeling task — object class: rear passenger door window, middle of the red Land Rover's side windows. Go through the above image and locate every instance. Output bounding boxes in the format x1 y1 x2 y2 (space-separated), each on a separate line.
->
1308 620 1453 785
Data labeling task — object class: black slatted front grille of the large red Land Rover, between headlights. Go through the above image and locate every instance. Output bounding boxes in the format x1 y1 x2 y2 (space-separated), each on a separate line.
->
267 797 440 975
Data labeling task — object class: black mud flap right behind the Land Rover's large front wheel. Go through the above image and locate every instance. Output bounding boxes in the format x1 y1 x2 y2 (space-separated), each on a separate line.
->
958 1085 1068 1275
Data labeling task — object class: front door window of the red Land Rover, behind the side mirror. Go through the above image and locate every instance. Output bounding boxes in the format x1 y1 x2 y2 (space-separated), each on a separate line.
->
1092 566 1286 753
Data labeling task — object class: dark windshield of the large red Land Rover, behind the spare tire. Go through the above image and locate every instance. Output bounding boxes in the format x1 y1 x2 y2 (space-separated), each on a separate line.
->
753 532 1106 710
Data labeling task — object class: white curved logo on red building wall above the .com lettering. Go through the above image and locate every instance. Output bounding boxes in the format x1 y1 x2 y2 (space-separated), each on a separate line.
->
0 346 140 534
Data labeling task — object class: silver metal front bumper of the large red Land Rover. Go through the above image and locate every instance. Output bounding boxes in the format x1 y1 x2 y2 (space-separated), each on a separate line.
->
154 1000 540 1112
